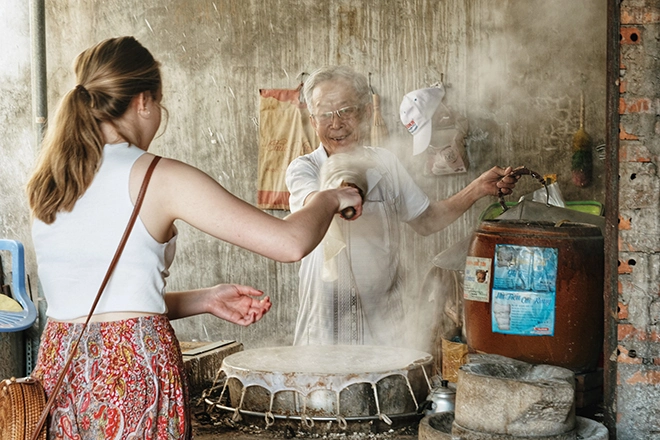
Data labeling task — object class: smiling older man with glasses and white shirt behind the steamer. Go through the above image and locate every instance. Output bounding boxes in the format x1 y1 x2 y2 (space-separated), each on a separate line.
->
286 66 515 346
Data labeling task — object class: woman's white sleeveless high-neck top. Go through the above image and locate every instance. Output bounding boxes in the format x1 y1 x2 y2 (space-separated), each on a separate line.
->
32 143 176 321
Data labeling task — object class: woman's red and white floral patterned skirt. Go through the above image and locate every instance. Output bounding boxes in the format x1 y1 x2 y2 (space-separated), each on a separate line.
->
32 316 191 439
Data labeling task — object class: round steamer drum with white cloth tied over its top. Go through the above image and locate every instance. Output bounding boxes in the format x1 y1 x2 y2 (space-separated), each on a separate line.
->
221 345 433 429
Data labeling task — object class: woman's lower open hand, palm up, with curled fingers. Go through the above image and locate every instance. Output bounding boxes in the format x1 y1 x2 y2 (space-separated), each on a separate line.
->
207 284 272 326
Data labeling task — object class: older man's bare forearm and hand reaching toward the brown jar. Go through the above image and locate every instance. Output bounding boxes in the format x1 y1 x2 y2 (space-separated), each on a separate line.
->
408 166 518 236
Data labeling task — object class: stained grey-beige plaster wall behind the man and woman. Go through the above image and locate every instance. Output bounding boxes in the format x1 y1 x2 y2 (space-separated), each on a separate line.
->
0 0 606 388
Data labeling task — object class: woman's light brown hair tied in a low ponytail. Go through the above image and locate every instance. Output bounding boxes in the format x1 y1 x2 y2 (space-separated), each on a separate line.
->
27 37 161 224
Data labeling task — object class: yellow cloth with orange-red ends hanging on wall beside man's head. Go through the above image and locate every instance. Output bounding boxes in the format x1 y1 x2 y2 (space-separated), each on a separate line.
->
257 84 319 210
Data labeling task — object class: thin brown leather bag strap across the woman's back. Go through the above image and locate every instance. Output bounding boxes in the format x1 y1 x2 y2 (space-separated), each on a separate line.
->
31 156 161 440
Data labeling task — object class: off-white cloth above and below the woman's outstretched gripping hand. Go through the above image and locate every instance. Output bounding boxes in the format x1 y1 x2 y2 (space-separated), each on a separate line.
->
321 148 369 281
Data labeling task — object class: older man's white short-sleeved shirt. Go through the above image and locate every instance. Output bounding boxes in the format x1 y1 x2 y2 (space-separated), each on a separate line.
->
286 145 429 346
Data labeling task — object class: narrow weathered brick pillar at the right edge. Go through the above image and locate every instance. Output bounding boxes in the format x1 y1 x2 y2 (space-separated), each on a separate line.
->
613 0 660 439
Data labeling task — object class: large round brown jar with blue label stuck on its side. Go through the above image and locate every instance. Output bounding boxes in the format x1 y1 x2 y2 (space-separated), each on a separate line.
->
464 220 604 372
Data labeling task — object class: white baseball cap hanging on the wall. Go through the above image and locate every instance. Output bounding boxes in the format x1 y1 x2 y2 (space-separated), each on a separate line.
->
399 84 445 155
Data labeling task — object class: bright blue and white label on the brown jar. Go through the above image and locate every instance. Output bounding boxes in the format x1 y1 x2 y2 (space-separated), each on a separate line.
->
491 244 559 336
